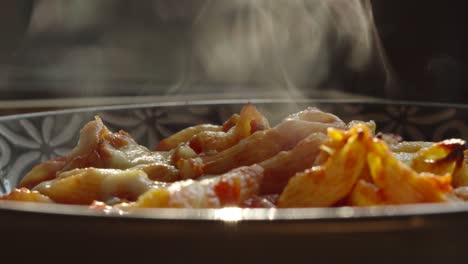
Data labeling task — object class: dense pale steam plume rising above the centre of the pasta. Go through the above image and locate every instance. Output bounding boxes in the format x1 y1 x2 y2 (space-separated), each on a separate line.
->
194 0 384 93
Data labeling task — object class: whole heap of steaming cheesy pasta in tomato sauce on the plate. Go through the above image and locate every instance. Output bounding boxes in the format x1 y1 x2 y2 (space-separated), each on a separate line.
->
0 103 468 210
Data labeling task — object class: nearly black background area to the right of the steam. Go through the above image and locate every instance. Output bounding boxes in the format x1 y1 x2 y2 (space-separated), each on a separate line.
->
373 0 468 103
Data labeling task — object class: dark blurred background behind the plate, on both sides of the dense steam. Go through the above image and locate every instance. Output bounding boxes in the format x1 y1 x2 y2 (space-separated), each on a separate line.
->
0 0 468 103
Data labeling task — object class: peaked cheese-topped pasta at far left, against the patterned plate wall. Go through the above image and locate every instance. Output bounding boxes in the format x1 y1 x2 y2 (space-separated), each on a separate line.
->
19 118 179 188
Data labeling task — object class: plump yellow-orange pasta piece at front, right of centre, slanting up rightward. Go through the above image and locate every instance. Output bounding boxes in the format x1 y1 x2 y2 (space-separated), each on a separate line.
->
278 125 372 207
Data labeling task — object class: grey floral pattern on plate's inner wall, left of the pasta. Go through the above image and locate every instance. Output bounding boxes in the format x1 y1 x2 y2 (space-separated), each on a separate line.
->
0 114 83 191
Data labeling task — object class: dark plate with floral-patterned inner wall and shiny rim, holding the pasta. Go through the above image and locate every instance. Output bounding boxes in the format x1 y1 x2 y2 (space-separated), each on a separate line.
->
0 100 468 263
